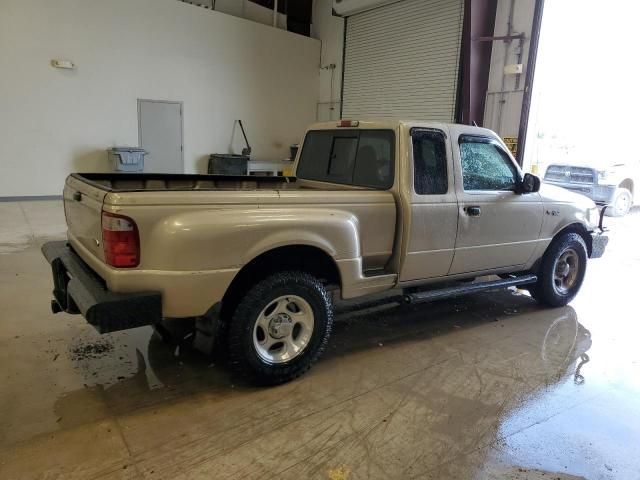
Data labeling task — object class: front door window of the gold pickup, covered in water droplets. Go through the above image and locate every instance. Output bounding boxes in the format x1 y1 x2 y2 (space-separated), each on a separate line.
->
460 136 518 190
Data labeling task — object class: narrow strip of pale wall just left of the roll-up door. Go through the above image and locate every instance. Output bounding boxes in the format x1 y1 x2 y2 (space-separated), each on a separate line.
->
311 0 345 121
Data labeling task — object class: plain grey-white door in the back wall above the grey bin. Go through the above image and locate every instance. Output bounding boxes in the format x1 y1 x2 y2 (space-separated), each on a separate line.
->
138 100 184 173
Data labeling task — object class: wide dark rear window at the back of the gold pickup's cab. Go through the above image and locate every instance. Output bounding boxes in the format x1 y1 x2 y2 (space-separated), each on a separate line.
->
297 130 395 190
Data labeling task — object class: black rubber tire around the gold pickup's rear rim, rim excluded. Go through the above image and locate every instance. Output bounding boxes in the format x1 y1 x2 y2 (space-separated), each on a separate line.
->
227 271 333 385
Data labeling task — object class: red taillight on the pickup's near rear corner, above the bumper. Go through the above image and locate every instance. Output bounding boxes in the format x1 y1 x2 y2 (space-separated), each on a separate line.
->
102 212 140 268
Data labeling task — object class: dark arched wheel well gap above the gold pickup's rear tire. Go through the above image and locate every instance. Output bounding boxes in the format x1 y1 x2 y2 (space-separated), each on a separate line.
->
221 245 340 318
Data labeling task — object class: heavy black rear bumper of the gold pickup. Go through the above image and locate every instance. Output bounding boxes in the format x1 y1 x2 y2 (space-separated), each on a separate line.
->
42 241 162 333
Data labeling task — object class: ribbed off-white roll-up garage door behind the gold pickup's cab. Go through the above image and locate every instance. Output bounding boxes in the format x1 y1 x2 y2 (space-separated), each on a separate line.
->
342 0 463 122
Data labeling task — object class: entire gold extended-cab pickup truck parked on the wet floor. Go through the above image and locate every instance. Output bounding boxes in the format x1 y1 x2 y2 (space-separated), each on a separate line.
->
42 120 607 384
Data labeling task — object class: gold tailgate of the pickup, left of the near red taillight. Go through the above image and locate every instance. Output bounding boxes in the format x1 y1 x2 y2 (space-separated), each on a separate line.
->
64 176 107 261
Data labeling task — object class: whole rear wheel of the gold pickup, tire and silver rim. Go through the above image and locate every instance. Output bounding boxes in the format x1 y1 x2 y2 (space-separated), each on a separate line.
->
227 271 333 385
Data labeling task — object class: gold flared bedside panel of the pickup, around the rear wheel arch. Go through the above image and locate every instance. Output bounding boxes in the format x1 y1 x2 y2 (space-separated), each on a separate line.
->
99 190 396 317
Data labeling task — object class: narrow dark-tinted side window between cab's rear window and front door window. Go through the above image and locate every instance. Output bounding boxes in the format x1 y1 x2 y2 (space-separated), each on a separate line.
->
411 129 448 195
